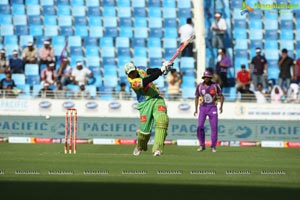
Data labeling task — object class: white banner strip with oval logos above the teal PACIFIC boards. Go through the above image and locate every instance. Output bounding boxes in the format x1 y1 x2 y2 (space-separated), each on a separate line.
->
0 99 300 120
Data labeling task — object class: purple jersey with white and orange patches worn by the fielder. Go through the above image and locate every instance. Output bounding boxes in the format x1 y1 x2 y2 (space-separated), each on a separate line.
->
195 83 222 106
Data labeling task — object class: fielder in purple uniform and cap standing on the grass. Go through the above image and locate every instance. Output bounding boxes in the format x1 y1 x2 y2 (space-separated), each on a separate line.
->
194 71 224 152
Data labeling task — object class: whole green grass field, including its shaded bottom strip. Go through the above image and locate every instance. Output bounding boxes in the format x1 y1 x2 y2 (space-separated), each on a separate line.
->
0 143 300 199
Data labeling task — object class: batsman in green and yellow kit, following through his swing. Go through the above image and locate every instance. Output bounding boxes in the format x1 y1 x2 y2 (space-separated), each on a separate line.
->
124 62 172 156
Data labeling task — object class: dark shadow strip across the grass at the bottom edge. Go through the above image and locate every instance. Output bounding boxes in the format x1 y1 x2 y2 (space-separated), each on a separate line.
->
0 181 300 200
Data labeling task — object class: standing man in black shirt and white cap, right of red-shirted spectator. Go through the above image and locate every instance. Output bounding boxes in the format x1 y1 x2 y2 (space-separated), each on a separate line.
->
250 48 268 88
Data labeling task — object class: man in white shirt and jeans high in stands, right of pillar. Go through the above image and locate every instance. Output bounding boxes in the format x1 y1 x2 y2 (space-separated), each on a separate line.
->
210 12 227 49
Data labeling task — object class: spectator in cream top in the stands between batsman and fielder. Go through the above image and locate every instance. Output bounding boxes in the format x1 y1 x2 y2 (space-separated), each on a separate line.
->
167 69 182 101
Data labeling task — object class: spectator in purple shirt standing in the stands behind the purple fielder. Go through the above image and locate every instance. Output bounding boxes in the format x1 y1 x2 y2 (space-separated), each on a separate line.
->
216 48 231 88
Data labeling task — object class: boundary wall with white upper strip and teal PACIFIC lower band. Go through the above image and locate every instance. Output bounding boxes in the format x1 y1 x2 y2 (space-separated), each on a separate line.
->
0 99 300 141
